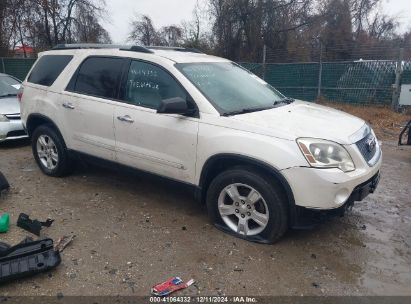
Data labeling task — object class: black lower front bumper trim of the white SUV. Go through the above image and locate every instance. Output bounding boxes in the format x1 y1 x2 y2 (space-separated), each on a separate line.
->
292 172 380 229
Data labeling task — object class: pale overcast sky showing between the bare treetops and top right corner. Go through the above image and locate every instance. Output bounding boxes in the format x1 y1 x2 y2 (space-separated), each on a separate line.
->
103 0 411 43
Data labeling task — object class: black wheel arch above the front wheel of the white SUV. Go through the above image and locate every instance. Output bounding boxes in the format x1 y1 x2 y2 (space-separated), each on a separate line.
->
200 154 296 222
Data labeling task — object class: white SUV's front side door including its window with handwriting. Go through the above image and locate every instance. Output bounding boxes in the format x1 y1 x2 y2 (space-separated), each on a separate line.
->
114 60 199 183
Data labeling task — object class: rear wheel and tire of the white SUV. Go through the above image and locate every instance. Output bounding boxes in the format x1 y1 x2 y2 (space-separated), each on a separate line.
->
31 125 74 177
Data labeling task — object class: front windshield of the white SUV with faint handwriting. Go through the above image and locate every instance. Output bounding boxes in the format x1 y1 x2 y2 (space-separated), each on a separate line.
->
176 62 285 115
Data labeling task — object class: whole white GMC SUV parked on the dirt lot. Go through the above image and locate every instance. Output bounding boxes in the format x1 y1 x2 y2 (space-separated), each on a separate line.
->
21 45 382 243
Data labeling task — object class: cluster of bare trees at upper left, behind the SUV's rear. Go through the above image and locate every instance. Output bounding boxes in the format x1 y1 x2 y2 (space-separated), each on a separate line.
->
0 0 110 50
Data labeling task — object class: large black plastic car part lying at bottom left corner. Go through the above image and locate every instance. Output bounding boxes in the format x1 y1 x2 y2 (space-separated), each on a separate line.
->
0 239 61 284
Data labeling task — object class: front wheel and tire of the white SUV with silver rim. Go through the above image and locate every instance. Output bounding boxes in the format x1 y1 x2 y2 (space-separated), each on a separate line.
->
207 168 288 244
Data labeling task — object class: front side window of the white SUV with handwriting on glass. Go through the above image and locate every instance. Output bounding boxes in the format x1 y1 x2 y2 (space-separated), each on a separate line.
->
125 61 187 109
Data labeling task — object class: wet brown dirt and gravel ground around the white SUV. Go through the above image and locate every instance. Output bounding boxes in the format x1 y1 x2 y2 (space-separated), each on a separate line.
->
0 142 411 296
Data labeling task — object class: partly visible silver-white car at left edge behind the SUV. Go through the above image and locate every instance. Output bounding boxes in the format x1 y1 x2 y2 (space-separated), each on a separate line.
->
0 73 27 142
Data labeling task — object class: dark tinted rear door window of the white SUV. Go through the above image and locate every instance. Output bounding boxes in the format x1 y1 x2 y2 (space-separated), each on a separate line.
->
69 57 124 99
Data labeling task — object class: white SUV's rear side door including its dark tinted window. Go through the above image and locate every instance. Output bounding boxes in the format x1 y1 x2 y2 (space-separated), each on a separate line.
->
61 56 126 160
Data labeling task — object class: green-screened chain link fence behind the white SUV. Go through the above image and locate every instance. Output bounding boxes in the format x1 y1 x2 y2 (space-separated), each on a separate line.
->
0 51 411 105
